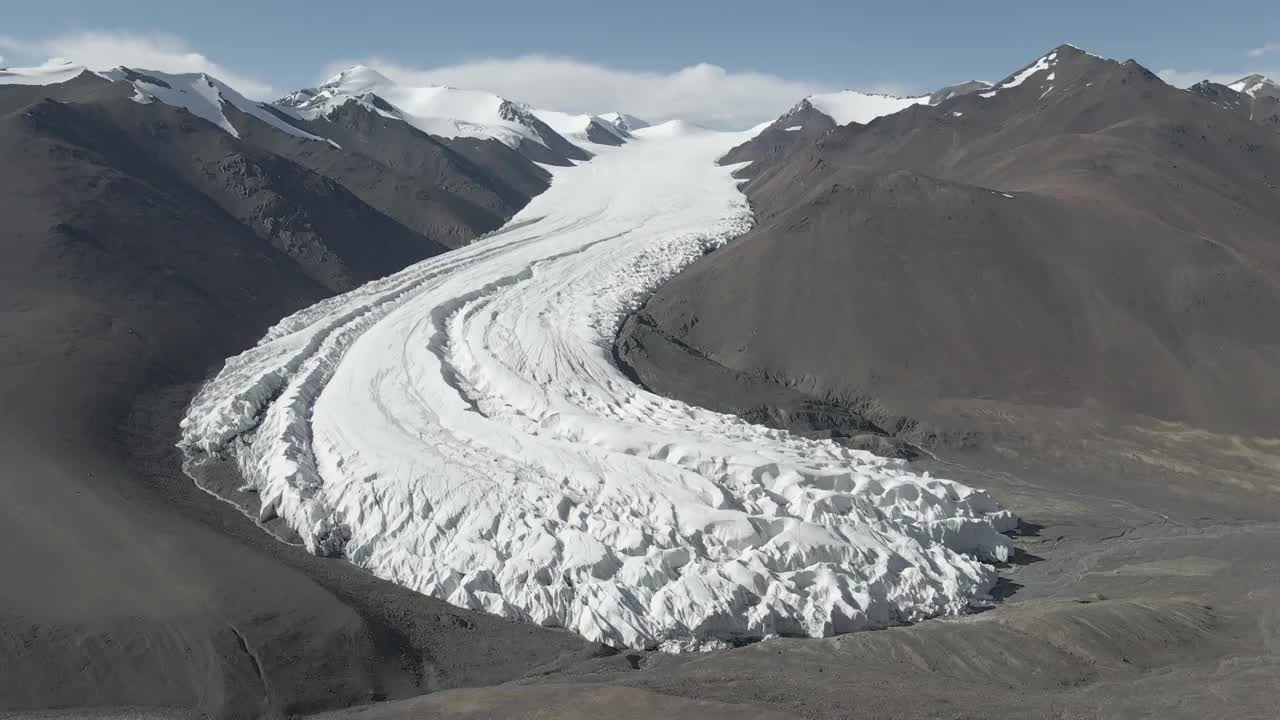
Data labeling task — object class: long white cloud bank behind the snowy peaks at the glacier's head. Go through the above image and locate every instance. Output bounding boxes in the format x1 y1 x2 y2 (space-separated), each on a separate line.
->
320 55 855 129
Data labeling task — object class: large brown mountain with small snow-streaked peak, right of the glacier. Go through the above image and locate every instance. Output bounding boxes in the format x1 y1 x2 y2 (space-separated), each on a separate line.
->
618 46 1280 442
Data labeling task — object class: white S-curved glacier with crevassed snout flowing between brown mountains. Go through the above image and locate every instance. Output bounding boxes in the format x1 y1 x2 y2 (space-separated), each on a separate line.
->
182 131 1016 648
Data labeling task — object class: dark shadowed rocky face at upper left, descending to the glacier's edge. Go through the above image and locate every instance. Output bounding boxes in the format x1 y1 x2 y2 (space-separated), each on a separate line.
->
6 81 445 291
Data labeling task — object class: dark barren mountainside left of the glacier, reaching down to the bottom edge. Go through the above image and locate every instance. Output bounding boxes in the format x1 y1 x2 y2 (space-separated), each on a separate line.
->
0 87 593 717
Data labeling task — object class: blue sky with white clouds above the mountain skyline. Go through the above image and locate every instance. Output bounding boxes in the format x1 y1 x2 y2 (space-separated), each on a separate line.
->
0 0 1280 127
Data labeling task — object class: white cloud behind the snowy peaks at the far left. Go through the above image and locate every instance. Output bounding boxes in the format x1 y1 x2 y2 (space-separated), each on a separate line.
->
0 31 274 99
